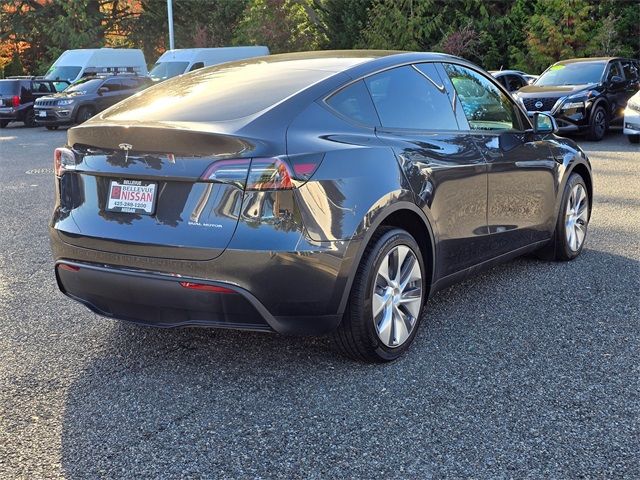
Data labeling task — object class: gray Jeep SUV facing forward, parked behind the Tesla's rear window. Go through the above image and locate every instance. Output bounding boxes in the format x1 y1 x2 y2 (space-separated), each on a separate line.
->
35 74 152 130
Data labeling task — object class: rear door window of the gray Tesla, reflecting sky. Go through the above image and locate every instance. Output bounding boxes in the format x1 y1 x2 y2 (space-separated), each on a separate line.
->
366 64 458 130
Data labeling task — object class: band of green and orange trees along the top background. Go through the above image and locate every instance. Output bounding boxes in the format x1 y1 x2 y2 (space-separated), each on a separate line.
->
0 0 640 75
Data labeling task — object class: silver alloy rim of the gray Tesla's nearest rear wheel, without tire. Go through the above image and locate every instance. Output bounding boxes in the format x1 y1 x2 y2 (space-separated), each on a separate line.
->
372 245 423 348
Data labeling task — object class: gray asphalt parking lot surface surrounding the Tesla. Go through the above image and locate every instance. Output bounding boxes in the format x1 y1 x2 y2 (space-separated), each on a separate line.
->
0 124 640 479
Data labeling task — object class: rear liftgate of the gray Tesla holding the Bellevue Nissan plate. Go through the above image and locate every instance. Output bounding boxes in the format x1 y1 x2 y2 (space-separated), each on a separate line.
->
54 126 277 260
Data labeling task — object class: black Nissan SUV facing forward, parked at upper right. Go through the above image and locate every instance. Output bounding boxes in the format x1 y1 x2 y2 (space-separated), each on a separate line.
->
515 57 640 140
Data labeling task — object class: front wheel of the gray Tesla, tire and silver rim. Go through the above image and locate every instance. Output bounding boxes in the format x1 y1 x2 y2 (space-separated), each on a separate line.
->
538 173 591 262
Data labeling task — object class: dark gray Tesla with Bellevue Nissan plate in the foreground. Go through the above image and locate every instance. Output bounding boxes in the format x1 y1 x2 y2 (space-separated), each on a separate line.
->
51 51 592 361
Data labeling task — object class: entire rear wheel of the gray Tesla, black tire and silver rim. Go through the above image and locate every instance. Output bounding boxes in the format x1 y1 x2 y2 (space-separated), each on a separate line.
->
335 228 426 362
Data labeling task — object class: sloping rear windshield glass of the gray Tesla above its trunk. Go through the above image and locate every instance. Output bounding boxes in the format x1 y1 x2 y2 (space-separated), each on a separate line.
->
105 62 334 122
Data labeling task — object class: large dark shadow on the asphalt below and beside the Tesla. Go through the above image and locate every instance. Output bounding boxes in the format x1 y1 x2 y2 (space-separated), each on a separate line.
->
61 250 640 479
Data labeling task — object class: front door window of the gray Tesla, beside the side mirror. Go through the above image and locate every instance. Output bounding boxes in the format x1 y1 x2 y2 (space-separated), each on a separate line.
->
443 63 520 131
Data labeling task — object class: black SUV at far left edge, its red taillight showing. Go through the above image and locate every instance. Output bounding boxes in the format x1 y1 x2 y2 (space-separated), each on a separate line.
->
0 77 69 128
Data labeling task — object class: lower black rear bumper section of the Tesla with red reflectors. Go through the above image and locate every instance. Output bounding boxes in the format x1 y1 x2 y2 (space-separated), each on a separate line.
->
55 260 340 335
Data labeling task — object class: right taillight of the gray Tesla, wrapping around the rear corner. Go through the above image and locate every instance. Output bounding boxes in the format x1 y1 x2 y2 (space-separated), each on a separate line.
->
201 155 322 190
